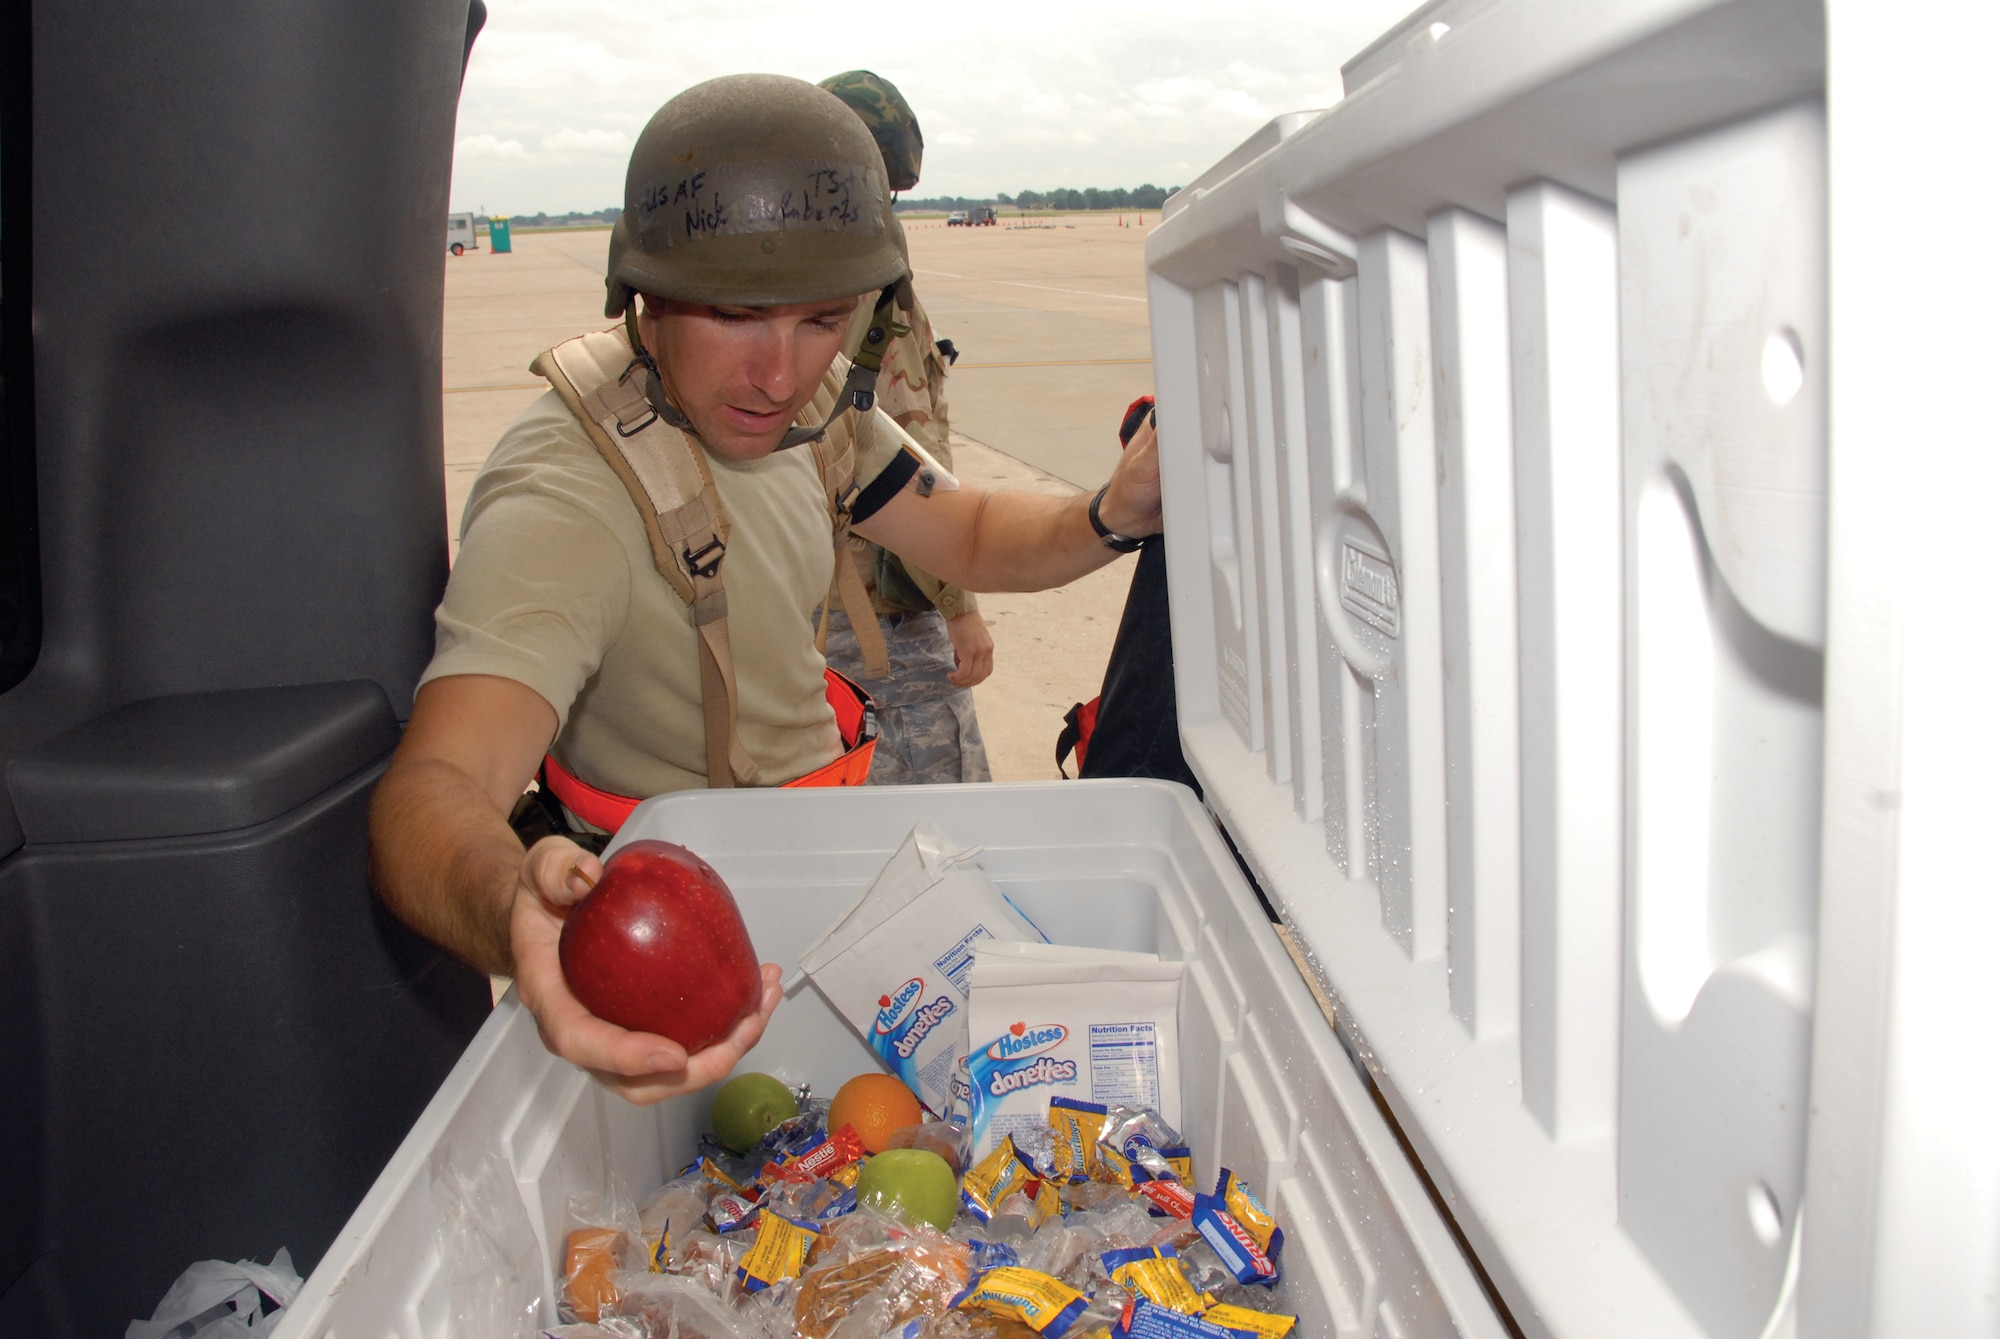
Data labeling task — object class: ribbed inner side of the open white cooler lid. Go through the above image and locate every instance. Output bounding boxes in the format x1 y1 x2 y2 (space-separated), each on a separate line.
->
1148 0 1886 1339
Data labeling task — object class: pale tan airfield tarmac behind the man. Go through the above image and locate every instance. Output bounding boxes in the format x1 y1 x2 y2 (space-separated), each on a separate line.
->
444 212 1160 781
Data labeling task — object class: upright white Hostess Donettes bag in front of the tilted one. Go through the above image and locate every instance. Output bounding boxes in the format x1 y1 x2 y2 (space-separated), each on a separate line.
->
966 941 1182 1175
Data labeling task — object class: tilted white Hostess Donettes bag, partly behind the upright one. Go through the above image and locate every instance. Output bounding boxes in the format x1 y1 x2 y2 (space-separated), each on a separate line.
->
798 819 1042 1117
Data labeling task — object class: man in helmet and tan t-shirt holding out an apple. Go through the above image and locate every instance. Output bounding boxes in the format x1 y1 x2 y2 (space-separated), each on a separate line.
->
370 76 1160 1101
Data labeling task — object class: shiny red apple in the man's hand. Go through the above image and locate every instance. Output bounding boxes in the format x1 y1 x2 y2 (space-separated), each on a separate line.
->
560 841 764 1053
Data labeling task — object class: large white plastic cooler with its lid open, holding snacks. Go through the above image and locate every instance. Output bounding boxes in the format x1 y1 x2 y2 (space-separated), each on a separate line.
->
278 0 2000 1339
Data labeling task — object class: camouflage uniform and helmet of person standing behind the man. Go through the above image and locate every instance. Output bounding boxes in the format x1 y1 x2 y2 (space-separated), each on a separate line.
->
820 70 992 785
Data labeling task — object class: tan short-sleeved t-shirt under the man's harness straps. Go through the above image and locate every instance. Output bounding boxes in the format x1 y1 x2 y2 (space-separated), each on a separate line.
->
434 392 916 795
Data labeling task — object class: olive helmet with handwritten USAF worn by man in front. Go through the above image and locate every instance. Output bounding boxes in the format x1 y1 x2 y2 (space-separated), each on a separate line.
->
604 74 910 316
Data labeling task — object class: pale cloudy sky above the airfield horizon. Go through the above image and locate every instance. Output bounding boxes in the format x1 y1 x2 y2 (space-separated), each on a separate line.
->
452 0 1416 214
